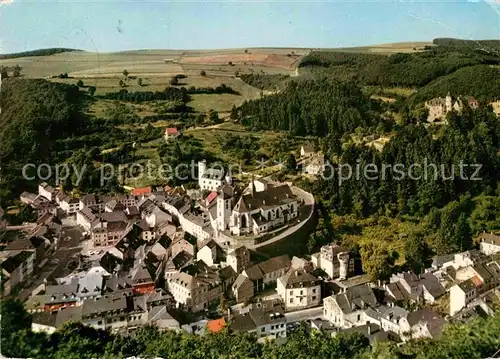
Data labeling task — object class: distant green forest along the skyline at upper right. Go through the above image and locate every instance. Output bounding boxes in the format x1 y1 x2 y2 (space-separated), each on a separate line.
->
299 39 500 87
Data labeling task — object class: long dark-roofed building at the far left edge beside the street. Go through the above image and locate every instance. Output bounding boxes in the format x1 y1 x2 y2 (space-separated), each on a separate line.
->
0 250 36 295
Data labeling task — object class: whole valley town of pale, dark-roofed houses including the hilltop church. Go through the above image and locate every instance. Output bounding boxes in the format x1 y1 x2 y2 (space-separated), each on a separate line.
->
0 172 500 341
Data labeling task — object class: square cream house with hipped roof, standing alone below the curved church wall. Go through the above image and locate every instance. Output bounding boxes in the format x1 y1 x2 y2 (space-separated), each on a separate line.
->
276 268 321 311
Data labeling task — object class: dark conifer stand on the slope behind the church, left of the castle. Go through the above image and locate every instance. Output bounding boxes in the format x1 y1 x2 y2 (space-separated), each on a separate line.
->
240 79 374 137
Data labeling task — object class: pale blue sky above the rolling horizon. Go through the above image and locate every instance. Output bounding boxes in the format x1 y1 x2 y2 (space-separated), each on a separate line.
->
0 0 500 53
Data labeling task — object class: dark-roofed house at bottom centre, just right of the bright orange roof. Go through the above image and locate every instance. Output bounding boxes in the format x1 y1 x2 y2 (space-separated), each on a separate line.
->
229 300 286 340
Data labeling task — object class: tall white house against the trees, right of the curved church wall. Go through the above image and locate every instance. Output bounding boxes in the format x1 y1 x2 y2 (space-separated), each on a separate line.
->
311 243 354 280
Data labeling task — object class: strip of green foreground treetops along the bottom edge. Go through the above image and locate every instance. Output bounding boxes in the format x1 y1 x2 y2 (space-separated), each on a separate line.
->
1 300 500 359
